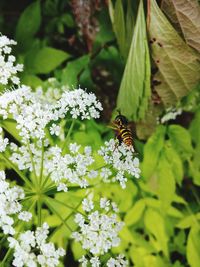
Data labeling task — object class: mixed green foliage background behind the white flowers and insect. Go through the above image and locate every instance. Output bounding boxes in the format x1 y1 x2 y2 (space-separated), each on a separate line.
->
0 0 200 267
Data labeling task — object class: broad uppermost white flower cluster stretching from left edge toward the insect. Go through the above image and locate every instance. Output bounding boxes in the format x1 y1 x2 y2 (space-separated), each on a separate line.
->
0 85 102 143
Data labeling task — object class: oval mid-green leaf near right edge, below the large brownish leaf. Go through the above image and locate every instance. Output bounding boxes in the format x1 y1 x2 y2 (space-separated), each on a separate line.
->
168 125 193 159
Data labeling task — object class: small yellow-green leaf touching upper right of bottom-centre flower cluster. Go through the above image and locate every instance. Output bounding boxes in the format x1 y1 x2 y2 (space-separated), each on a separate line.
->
124 199 145 226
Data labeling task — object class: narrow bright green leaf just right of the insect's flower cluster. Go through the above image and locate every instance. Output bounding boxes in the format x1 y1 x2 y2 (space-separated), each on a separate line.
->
142 125 166 179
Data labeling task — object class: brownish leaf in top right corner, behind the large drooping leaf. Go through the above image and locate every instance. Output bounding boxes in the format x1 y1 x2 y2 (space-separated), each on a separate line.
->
172 0 200 52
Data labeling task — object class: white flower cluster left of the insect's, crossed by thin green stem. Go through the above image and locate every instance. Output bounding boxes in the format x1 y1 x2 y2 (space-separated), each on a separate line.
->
10 143 94 191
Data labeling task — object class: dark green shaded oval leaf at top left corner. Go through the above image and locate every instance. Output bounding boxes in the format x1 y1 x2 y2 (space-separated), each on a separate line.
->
16 1 41 43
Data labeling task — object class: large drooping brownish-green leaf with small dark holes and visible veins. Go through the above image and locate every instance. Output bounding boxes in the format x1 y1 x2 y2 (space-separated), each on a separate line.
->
149 0 200 105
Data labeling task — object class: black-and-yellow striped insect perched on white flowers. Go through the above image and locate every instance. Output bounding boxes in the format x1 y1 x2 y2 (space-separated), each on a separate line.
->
110 111 133 147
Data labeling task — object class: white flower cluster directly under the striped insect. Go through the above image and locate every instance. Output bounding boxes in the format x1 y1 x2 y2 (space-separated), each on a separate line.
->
99 139 141 188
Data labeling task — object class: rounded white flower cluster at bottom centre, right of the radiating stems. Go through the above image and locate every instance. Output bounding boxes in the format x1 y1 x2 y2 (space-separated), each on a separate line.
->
72 199 123 256
